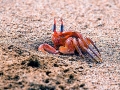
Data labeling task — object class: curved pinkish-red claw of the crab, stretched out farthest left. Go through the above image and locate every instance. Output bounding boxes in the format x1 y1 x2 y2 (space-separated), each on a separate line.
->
38 43 59 54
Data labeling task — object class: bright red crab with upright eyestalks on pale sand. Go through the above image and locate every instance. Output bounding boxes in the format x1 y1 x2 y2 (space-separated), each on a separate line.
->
38 18 102 62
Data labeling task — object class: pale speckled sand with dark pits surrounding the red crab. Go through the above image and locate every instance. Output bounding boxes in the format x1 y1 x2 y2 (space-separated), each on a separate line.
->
0 0 120 90
